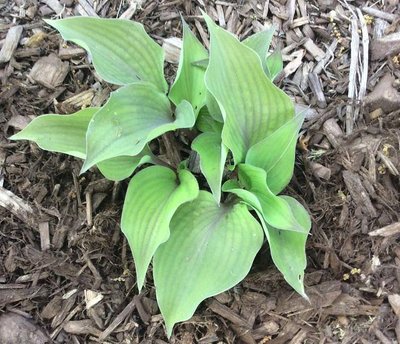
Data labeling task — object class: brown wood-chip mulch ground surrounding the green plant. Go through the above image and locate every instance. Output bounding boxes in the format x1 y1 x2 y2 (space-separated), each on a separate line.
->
0 0 400 344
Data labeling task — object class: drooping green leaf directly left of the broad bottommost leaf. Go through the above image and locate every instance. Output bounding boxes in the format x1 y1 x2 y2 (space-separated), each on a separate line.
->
121 166 199 291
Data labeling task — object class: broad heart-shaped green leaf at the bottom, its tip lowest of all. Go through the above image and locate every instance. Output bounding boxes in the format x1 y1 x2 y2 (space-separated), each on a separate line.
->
153 191 263 336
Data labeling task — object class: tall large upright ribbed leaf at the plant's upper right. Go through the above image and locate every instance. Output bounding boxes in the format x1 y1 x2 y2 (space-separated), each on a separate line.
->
204 15 294 164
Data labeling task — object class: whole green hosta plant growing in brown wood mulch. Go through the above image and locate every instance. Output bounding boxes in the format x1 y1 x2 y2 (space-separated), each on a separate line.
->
11 14 311 336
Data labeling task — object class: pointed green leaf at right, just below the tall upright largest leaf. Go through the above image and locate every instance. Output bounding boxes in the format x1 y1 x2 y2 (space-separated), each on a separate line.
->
246 113 304 194
